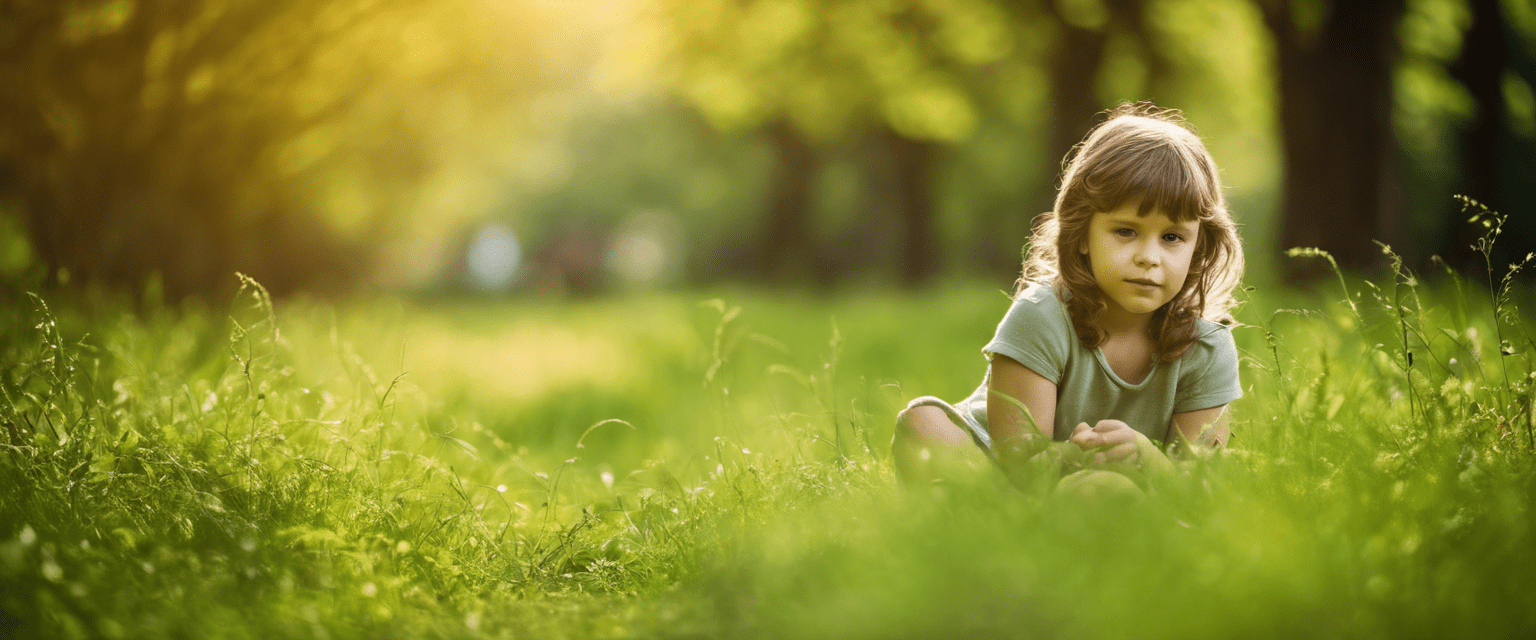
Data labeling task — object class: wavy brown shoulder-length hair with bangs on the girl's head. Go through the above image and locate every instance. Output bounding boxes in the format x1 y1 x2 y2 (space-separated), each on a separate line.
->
1015 103 1243 362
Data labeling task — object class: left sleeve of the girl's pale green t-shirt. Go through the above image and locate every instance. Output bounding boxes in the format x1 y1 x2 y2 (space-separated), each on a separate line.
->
982 284 1072 384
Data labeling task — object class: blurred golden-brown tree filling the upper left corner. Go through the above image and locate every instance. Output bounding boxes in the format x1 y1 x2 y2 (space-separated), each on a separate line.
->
0 0 546 295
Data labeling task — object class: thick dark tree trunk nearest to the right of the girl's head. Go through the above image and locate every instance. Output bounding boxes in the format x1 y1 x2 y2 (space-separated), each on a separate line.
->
1261 0 1407 271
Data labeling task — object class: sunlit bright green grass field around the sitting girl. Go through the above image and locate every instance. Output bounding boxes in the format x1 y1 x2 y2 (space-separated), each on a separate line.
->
0 234 1536 638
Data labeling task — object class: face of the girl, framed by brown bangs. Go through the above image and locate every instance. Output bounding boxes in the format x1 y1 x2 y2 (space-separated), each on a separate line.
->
1083 201 1200 316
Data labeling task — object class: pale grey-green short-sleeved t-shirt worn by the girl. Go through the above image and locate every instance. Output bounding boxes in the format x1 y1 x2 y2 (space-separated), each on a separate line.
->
954 284 1243 445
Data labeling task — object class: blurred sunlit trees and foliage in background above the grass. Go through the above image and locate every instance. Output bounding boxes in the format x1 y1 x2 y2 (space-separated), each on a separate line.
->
0 0 1536 298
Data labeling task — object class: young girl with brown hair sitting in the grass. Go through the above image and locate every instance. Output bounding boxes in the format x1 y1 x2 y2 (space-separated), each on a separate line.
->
894 103 1243 480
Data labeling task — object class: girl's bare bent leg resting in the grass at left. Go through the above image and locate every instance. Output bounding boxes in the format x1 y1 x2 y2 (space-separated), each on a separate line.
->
891 405 986 485
